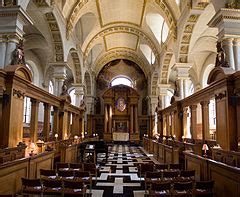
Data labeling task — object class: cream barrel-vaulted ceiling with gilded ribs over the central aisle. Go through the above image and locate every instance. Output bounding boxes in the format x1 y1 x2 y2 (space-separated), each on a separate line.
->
63 0 179 75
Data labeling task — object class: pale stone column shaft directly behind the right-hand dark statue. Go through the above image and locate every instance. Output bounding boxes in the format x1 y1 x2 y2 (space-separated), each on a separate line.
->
223 38 235 70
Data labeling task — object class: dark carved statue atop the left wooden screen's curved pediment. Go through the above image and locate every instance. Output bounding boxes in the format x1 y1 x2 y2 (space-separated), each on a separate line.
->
10 40 26 65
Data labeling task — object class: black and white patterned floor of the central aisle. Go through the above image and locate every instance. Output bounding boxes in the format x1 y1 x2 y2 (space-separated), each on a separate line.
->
89 145 158 197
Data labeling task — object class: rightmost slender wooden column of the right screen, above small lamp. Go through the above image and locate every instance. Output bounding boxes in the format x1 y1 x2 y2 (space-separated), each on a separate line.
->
200 101 210 140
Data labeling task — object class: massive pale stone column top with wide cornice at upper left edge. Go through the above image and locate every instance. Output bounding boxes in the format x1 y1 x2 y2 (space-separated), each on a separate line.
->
0 3 33 68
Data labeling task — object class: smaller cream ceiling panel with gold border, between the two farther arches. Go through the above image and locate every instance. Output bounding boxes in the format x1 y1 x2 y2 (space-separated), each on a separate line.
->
105 33 138 50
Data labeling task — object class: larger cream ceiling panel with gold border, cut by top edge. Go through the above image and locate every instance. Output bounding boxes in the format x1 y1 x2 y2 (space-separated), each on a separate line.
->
97 0 146 26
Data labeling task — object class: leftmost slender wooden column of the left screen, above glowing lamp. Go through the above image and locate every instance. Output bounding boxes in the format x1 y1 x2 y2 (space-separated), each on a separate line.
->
30 98 39 142
